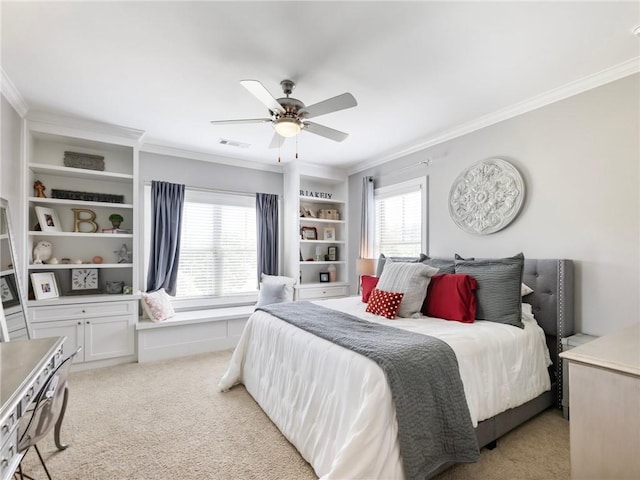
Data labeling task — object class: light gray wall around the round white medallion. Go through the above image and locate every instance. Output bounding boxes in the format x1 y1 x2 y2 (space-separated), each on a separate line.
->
349 74 640 335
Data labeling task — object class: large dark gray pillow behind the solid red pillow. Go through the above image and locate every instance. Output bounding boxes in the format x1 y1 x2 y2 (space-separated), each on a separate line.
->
456 253 524 328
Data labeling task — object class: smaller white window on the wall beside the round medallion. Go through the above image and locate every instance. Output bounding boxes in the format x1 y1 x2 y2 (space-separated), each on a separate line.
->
374 177 427 257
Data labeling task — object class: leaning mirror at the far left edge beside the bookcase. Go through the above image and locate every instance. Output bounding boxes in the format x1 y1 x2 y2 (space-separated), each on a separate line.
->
0 198 31 342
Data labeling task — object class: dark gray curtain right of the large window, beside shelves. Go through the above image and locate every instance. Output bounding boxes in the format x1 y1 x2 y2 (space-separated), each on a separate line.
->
256 193 278 283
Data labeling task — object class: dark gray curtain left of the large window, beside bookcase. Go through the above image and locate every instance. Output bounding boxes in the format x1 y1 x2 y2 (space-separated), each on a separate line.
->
147 180 184 295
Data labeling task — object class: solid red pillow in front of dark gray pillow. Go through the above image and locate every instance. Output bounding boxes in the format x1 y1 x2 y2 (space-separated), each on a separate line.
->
422 273 478 323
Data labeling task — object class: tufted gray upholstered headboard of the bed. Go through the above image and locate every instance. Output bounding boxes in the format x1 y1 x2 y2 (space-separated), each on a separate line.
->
522 259 574 405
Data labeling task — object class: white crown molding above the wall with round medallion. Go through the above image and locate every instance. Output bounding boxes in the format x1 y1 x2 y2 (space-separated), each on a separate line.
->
349 57 640 175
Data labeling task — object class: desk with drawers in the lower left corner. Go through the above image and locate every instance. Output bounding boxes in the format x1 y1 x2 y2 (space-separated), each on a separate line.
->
0 337 65 480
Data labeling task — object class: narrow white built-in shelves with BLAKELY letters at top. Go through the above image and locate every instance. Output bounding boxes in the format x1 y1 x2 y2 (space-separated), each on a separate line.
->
284 164 349 300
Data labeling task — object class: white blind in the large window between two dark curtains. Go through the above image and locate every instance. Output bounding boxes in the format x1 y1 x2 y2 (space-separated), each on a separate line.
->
176 191 257 297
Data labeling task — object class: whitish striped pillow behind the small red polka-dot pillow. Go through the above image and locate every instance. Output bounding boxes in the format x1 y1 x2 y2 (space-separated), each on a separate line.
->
376 260 438 318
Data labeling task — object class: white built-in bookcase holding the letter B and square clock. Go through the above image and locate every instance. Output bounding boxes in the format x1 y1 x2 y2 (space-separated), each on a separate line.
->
22 122 139 363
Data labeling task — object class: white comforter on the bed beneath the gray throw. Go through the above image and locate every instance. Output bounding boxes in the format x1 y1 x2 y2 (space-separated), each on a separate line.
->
219 297 551 479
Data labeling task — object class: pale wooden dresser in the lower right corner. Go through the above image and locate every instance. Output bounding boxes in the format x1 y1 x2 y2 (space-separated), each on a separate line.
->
560 323 640 480
